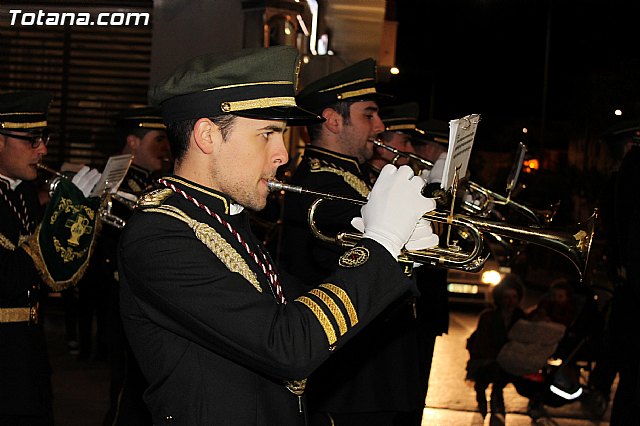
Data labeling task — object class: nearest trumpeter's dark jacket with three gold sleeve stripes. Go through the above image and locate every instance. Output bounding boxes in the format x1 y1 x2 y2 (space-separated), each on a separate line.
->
119 177 415 426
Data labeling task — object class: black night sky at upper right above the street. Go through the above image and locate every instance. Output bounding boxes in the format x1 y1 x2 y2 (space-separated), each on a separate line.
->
382 0 640 151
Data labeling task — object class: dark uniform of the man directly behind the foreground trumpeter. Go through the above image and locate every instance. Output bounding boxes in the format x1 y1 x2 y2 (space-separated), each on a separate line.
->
282 146 426 413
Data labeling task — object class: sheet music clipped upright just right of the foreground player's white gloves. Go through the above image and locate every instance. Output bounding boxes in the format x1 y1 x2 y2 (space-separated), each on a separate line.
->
440 114 480 190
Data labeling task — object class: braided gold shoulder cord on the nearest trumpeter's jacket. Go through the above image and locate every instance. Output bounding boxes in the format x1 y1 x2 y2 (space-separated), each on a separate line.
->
142 205 262 293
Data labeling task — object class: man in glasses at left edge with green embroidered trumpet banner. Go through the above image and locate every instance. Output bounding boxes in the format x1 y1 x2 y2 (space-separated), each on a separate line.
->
0 92 100 426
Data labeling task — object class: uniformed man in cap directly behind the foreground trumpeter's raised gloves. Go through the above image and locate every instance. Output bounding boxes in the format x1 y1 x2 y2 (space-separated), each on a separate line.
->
281 59 437 426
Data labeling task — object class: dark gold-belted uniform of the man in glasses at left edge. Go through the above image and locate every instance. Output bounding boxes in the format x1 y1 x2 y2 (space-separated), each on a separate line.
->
0 177 51 417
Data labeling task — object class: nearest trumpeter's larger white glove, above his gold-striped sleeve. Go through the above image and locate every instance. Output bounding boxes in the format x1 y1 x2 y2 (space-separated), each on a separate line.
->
361 164 436 258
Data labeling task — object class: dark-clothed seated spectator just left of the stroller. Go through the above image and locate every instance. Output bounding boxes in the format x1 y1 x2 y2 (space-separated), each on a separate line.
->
467 274 525 417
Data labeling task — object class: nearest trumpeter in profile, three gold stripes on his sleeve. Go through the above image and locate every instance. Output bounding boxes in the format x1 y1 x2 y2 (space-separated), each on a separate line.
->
118 46 434 426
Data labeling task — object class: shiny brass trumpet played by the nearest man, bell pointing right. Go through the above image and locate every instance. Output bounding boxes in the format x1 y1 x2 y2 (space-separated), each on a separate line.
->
268 179 598 280
